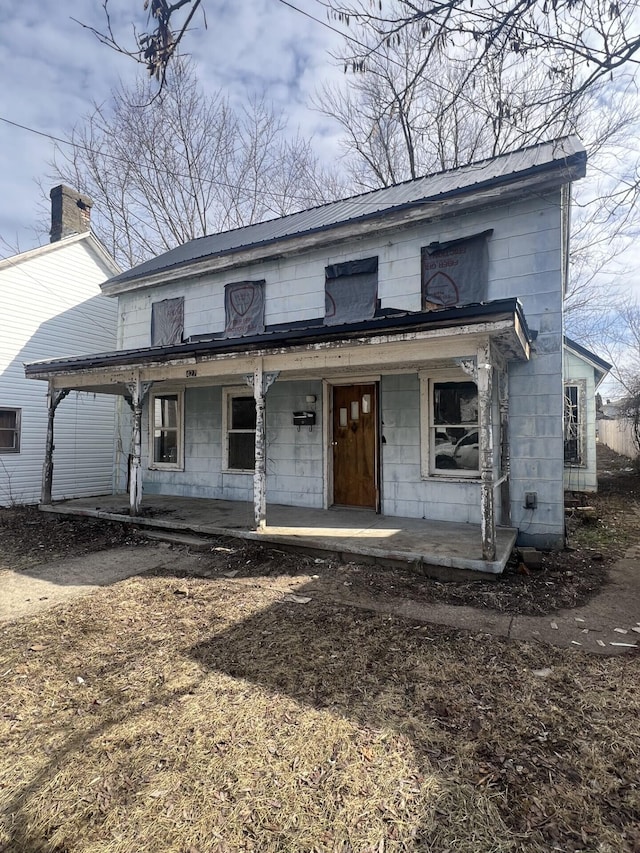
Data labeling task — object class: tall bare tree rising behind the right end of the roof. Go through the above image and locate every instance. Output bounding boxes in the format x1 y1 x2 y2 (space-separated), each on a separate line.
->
316 9 640 339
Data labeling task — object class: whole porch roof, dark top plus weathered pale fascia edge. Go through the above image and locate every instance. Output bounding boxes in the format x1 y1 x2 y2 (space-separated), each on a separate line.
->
25 298 533 384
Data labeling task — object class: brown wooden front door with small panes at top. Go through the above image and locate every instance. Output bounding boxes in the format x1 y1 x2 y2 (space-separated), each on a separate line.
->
333 385 378 509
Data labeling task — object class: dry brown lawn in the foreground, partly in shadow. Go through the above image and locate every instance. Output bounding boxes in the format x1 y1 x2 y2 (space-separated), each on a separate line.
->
0 564 640 853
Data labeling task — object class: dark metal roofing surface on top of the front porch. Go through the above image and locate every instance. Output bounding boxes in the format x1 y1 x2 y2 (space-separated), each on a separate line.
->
25 298 532 376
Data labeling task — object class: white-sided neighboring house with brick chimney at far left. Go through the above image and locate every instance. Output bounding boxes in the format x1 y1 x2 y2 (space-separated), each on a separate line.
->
0 186 119 506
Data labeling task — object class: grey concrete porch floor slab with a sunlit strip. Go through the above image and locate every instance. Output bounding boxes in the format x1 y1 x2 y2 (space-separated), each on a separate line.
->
40 495 517 577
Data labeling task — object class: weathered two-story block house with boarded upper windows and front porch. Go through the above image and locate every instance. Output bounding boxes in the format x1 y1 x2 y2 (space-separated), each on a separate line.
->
27 137 586 571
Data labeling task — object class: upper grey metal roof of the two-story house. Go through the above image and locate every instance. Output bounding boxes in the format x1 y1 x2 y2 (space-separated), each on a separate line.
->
106 136 586 289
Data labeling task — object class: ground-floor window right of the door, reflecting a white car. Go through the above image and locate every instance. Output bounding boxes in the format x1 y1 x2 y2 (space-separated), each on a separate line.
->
422 379 480 477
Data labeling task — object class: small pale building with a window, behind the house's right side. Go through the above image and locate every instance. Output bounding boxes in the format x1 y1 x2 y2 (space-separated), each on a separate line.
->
564 337 611 492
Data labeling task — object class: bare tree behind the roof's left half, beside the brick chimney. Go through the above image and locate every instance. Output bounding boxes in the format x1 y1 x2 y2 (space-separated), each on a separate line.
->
49 62 340 266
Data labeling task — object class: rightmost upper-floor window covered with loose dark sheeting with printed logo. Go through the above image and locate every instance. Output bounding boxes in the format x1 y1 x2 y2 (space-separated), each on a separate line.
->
422 231 492 311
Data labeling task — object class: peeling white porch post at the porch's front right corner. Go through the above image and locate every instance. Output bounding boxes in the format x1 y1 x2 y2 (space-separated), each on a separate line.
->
477 342 496 560
